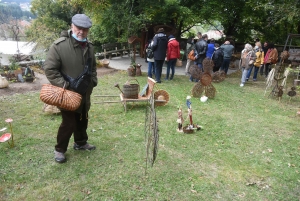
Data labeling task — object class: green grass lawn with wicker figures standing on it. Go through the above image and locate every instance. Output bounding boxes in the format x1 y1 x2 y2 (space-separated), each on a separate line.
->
0 71 300 201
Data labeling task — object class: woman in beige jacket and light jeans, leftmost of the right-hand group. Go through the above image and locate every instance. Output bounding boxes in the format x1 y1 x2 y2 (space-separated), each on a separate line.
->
240 43 256 87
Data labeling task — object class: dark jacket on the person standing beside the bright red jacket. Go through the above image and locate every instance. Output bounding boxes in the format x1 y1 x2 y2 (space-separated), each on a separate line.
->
152 33 168 60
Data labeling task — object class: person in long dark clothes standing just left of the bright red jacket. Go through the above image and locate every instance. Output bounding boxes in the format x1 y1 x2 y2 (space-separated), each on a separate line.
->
152 28 168 83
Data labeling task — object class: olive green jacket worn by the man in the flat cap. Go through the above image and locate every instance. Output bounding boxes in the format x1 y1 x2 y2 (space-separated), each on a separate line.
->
43 30 98 113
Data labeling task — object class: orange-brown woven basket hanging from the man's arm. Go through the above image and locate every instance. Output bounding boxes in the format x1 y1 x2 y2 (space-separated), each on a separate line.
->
40 84 82 111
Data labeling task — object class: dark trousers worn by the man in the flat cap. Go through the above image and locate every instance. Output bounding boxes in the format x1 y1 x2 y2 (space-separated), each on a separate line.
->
55 109 88 153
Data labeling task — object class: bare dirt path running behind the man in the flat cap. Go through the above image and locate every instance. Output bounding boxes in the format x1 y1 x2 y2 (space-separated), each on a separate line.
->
0 67 118 97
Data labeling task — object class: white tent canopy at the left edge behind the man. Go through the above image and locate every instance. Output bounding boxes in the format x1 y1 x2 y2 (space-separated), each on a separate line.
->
0 41 36 55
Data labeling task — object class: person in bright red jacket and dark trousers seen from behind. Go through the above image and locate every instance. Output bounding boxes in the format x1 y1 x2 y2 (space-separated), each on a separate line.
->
165 35 180 80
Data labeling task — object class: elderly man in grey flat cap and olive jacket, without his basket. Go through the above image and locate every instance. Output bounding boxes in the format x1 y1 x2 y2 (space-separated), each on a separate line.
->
44 14 98 163
